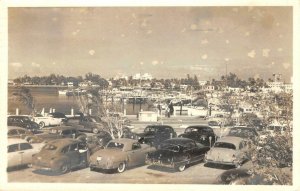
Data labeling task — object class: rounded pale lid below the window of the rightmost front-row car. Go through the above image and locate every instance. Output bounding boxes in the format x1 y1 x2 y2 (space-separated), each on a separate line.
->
207 147 237 161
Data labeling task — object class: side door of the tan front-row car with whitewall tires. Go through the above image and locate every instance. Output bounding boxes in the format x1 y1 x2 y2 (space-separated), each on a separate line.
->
127 142 146 166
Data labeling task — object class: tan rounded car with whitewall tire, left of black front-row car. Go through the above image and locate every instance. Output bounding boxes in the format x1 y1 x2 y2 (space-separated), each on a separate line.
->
90 138 154 173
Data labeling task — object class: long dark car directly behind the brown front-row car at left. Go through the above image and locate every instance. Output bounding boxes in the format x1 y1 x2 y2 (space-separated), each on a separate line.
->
26 126 87 142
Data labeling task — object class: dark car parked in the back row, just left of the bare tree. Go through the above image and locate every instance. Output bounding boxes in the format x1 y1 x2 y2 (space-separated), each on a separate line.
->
78 115 107 134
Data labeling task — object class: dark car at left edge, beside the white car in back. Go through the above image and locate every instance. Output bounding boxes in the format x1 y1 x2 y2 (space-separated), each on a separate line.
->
7 115 40 132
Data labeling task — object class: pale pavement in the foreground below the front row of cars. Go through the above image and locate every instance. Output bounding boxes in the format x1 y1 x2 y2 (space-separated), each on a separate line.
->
7 163 234 184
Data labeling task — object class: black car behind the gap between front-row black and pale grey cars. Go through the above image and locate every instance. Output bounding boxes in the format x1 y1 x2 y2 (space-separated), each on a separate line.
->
178 125 217 146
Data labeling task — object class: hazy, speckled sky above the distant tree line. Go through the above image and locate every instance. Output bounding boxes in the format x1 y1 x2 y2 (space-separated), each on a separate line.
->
8 7 293 82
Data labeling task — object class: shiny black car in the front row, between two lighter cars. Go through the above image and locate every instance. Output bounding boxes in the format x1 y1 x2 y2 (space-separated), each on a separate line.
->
146 138 210 172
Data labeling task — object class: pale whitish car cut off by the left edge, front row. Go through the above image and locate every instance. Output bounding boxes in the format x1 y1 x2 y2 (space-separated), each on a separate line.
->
7 138 43 169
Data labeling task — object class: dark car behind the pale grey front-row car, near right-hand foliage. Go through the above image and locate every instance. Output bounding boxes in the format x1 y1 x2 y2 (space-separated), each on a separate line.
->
227 126 258 142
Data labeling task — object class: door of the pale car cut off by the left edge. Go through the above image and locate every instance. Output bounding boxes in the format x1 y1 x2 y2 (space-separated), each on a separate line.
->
7 143 22 167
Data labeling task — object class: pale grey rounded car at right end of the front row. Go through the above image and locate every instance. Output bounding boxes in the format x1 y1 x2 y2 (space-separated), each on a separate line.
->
205 136 249 167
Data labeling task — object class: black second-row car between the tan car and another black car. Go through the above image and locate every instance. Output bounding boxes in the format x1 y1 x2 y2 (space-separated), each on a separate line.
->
138 125 177 147
